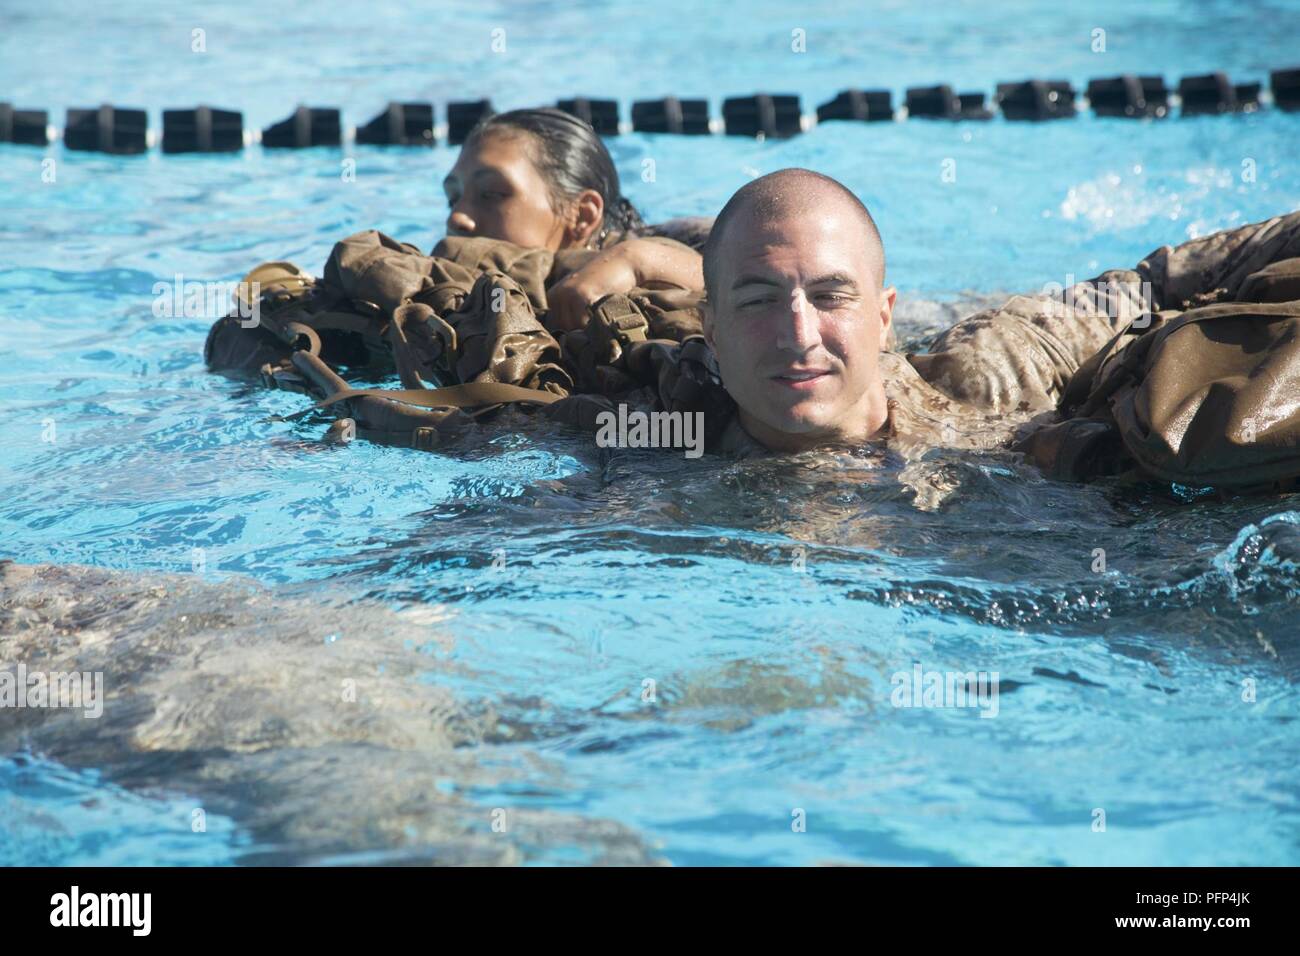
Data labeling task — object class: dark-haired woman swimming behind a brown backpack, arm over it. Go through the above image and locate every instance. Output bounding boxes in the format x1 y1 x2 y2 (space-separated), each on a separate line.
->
434 109 703 332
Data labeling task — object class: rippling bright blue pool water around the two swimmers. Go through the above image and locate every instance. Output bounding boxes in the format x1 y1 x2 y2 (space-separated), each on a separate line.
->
0 0 1300 865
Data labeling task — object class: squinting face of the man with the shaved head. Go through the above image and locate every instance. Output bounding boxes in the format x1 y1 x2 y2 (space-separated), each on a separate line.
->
705 202 896 450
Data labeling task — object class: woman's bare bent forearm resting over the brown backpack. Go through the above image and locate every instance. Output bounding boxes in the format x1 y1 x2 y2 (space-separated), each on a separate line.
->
546 237 705 332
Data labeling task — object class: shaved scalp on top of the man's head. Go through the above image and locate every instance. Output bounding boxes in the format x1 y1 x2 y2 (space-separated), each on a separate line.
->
703 168 885 302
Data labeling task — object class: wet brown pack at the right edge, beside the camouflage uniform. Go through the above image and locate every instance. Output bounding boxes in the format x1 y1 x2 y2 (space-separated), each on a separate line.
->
1018 259 1300 490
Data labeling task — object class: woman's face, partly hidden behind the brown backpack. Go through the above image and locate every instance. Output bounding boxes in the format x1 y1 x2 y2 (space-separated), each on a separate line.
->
442 133 571 251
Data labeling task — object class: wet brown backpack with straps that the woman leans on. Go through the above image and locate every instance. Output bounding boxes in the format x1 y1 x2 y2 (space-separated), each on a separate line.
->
204 232 717 450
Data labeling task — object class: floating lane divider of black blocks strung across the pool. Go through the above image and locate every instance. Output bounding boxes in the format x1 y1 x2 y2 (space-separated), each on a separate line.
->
0 66 1300 155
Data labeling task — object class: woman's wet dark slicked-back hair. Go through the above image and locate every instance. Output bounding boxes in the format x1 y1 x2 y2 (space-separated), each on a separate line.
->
465 108 646 248
